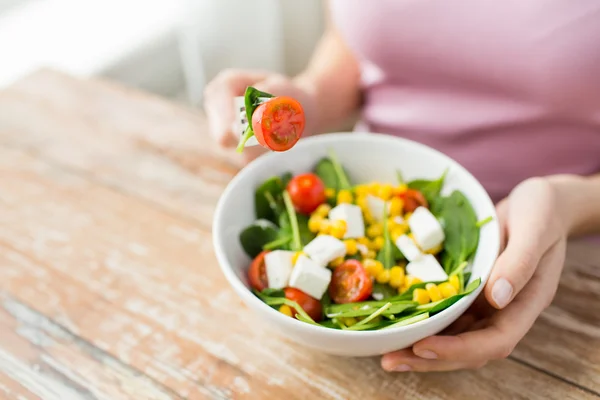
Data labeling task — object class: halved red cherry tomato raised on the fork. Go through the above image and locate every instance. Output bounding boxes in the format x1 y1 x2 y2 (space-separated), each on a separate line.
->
252 96 306 151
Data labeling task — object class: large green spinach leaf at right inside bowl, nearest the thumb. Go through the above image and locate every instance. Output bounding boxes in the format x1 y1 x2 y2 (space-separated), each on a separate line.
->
432 190 479 273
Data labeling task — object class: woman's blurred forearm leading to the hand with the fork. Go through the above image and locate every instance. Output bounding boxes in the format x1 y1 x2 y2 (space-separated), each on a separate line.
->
294 14 361 133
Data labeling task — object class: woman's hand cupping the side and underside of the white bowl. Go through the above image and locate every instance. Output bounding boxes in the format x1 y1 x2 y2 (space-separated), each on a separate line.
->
381 178 570 372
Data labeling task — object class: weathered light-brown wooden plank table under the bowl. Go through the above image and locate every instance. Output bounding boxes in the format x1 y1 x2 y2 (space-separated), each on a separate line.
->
0 71 600 400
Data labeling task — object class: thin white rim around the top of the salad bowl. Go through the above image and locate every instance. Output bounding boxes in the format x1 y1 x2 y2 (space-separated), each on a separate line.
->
212 131 500 338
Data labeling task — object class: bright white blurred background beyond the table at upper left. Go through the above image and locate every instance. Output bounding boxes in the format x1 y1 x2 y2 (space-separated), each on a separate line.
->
0 0 324 105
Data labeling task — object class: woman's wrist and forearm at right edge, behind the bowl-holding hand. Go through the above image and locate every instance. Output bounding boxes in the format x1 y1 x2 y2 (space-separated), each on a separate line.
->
548 174 600 236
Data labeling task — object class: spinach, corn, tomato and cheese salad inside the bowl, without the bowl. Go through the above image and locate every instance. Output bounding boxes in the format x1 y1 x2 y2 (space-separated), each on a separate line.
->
240 153 491 331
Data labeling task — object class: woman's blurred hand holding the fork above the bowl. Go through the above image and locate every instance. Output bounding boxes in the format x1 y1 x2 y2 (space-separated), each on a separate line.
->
204 70 314 161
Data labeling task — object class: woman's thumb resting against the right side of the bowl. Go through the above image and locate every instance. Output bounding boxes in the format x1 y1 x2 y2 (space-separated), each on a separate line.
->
485 179 560 308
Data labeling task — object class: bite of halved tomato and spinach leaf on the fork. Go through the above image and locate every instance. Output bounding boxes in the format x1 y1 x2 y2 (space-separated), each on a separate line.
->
236 86 306 153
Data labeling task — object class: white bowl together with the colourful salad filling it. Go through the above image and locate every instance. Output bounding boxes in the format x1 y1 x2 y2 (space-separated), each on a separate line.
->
213 133 500 356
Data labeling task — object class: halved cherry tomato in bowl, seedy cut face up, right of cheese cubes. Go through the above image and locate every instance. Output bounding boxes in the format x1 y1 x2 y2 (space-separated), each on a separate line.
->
329 260 373 304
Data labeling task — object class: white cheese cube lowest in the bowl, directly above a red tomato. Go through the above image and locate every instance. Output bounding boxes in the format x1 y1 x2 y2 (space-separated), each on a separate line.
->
290 255 331 300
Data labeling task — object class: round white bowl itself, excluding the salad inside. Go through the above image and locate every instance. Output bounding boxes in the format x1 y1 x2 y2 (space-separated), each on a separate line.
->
213 133 500 357
